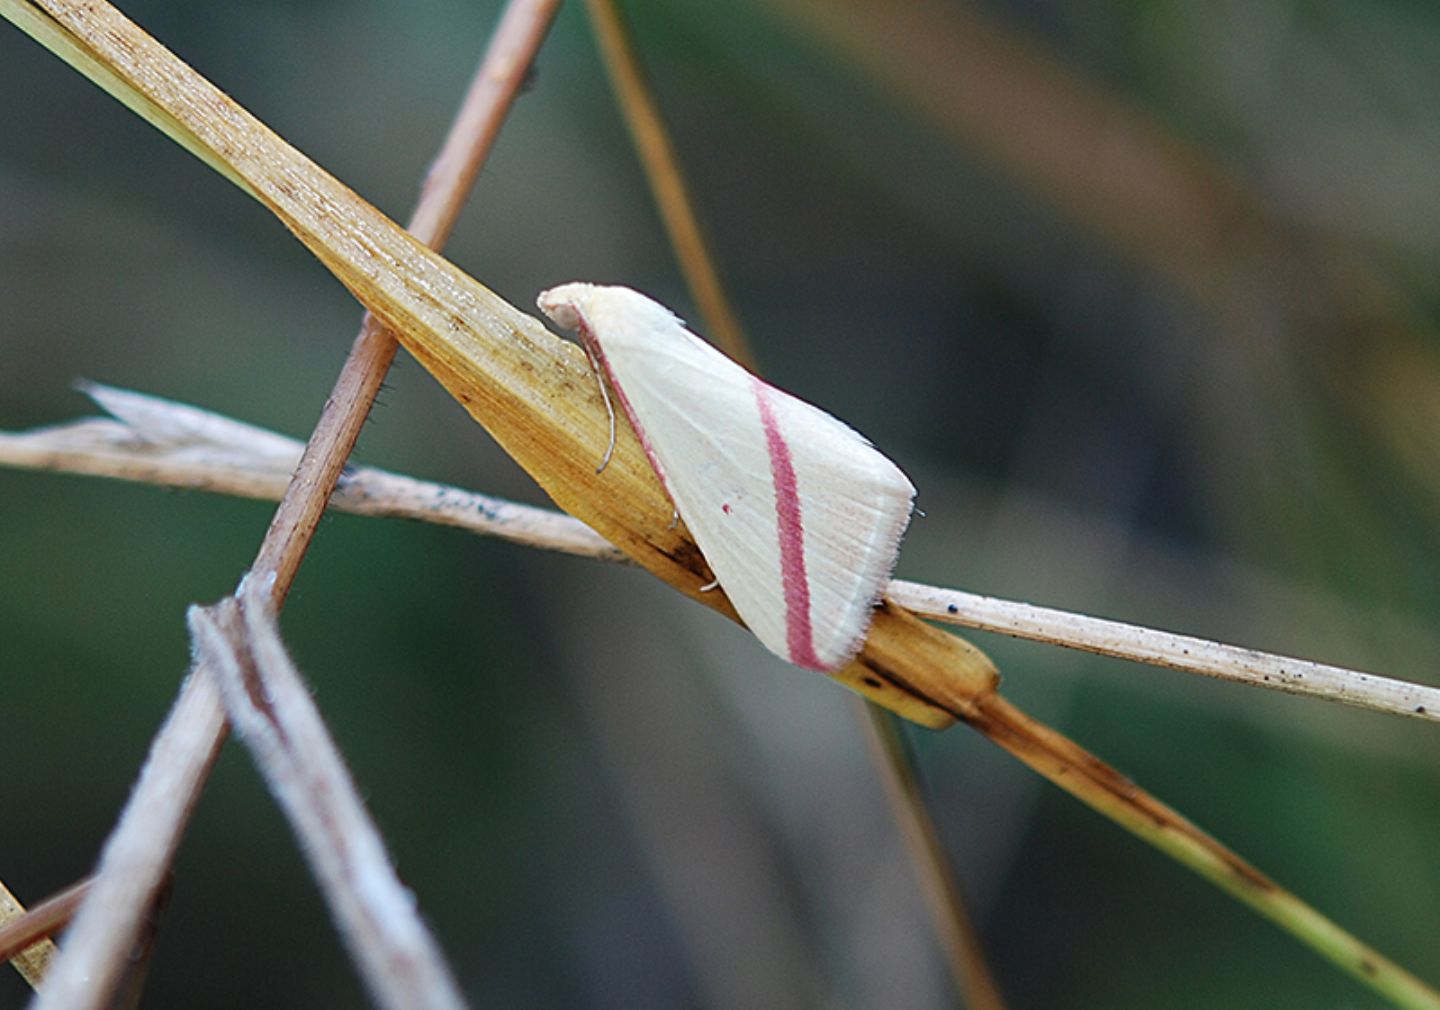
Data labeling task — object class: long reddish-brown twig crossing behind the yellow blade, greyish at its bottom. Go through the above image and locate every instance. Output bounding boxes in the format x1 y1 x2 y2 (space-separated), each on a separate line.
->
26 0 557 1010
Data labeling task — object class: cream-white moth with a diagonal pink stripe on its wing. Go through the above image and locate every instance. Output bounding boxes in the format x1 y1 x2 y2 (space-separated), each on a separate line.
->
537 282 914 670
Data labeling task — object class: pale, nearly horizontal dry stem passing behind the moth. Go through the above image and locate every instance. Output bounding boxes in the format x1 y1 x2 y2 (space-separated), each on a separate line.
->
0 383 1440 720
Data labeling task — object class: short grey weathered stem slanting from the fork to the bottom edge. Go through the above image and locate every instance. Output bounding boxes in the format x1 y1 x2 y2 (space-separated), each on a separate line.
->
190 581 465 1010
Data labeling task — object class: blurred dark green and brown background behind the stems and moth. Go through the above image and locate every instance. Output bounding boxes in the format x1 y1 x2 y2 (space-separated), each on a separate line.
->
0 0 1440 1010
